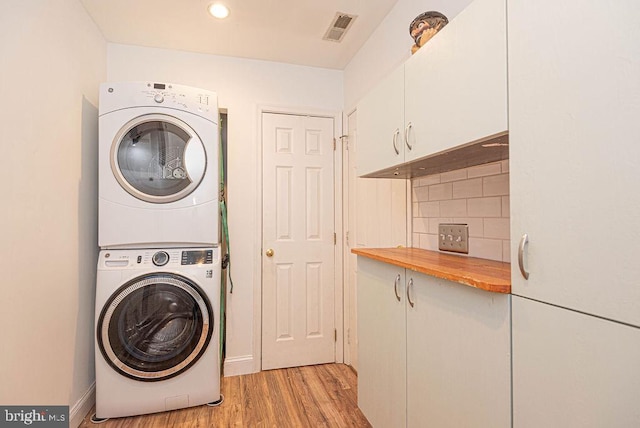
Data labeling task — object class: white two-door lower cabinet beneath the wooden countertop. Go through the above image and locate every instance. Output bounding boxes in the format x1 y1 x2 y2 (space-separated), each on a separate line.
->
358 257 511 428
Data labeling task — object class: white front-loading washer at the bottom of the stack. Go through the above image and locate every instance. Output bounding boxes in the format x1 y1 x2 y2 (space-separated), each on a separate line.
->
95 247 221 418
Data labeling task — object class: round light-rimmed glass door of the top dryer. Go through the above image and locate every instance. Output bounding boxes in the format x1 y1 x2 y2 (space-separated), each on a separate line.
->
111 114 207 204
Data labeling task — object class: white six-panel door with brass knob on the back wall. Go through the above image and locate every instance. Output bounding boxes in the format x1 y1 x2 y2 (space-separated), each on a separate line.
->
262 113 335 370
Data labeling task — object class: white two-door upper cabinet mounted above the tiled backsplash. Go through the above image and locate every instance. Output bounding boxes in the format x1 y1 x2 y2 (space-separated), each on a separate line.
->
357 0 507 178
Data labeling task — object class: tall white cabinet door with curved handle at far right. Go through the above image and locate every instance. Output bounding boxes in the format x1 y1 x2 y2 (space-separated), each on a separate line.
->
508 0 640 326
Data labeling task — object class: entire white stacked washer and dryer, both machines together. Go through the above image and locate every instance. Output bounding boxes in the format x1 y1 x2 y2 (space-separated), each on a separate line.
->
94 82 222 421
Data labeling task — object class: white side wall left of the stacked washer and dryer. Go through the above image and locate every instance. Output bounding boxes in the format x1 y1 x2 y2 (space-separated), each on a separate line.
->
0 0 106 417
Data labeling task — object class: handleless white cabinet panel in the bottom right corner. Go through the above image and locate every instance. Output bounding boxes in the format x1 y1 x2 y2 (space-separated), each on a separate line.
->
512 296 640 428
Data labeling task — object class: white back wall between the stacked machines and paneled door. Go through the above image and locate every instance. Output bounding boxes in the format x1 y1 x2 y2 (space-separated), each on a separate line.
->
107 44 343 375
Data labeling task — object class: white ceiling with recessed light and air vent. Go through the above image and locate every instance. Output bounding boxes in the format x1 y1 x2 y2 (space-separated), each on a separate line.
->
80 0 400 70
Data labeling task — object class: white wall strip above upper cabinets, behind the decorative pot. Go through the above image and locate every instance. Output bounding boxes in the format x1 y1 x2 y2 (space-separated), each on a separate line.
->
344 0 472 112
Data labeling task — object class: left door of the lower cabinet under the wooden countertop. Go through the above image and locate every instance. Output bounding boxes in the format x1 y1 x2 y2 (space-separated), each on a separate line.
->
357 257 407 427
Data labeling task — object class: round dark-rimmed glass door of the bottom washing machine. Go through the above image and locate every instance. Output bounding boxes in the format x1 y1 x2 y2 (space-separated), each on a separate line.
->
97 273 214 381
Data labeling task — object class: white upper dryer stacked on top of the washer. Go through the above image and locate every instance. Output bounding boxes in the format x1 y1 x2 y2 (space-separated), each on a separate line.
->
98 82 220 249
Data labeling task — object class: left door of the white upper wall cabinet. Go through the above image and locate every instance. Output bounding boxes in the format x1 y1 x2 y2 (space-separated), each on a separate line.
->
356 67 404 176
